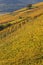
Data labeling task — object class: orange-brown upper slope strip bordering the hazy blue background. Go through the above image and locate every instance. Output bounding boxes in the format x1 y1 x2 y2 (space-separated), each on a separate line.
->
0 2 43 24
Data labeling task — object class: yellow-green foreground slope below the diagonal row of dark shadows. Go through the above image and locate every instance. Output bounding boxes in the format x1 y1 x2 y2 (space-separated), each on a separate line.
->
0 2 43 65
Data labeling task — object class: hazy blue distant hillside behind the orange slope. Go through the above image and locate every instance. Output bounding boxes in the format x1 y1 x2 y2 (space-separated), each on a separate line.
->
0 0 43 14
